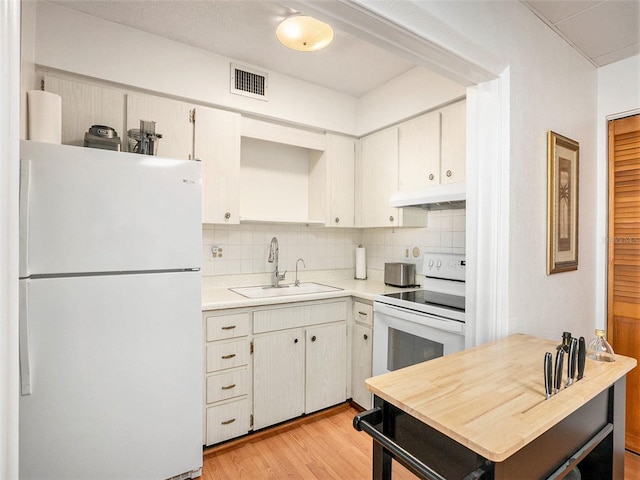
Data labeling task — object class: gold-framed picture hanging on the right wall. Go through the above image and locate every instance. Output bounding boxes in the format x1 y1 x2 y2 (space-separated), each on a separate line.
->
547 131 580 275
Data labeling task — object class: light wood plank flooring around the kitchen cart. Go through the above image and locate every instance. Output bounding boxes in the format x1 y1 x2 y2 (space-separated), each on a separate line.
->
202 404 640 480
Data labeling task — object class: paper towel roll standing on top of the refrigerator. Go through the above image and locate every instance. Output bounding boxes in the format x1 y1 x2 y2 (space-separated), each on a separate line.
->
27 90 62 143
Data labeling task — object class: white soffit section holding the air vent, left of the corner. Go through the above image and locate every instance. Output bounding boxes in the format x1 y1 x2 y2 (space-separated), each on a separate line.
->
36 1 356 134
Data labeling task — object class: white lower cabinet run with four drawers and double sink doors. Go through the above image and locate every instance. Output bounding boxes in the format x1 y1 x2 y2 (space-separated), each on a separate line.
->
203 299 351 445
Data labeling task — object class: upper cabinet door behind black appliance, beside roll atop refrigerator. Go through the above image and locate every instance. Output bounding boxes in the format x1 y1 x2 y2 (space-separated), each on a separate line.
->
44 76 127 151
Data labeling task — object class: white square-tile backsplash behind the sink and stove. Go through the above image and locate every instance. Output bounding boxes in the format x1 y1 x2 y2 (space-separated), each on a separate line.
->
202 209 466 277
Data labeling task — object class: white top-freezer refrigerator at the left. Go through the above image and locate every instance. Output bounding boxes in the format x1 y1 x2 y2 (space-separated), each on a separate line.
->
19 141 202 480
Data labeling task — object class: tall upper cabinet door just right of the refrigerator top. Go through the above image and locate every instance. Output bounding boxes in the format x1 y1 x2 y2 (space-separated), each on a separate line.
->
194 107 240 224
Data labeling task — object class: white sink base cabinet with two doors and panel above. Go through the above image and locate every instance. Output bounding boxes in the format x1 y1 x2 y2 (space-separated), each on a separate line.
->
253 300 347 429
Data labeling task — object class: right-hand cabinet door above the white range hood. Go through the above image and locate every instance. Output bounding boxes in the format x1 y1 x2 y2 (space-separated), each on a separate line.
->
440 101 467 183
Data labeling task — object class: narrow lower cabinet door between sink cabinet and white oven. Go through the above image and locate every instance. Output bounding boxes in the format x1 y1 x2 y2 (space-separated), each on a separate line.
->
351 323 373 410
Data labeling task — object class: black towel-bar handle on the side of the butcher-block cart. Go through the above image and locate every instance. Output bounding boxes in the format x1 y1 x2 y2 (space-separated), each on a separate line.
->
353 407 493 480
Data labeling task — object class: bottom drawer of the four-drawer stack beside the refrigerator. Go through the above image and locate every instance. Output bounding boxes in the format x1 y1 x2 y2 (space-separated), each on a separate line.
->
207 397 250 445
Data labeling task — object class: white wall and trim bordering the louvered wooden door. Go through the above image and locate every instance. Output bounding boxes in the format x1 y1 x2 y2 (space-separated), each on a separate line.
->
596 55 640 328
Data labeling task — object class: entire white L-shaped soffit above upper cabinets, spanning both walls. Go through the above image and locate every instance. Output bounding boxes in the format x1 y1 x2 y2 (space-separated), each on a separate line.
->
36 1 465 136
